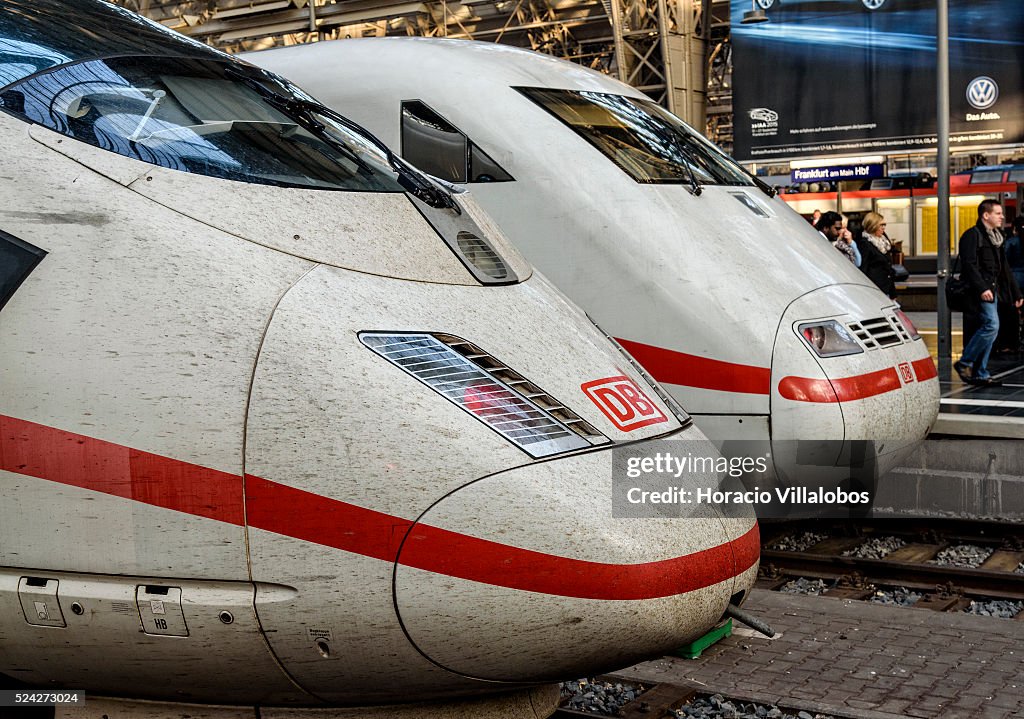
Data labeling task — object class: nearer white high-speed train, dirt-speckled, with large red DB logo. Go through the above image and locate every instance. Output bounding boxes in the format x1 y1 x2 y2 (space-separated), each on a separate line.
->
0 0 759 717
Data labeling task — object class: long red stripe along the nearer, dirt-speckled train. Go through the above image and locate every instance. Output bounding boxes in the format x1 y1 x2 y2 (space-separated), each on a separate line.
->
0 416 760 600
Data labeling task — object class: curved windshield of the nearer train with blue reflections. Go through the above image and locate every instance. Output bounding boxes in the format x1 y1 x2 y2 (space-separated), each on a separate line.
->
0 57 404 193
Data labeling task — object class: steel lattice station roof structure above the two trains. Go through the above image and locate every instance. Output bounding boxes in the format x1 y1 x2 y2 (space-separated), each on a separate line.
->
114 0 732 150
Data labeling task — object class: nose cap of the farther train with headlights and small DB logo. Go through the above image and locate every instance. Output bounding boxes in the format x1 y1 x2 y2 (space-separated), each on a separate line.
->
771 285 939 476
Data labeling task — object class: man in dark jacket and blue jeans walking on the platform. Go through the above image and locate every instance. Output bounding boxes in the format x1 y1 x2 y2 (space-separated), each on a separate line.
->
953 200 1024 387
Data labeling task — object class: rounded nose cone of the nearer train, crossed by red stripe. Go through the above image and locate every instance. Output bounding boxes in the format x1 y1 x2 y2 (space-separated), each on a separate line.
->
394 442 759 682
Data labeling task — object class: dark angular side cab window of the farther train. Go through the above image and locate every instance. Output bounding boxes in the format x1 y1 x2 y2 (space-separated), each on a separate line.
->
401 100 513 184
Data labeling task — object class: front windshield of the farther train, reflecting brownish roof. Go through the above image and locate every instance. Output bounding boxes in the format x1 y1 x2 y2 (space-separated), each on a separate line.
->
516 87 754 185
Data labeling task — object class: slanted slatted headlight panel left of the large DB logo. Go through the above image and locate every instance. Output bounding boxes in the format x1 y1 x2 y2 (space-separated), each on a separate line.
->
359 333 608 457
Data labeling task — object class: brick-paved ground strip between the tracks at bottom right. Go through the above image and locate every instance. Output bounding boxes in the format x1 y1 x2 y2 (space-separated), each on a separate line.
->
615 589 1024 719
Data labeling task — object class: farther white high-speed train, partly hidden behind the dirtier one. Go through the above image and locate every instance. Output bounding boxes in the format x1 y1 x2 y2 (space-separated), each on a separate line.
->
245 38 939 487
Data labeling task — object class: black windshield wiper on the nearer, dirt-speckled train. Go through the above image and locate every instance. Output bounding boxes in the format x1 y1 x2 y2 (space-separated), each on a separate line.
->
230 66 462 214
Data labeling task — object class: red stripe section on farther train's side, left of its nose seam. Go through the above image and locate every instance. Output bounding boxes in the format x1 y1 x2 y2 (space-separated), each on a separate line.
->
615 338 771 394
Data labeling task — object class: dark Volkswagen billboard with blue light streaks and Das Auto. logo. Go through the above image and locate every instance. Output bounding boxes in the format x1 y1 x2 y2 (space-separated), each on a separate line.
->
730 0 1024 162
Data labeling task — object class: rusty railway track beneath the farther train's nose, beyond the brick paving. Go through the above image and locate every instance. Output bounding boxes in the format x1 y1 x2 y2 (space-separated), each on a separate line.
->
759 519 1024 621
